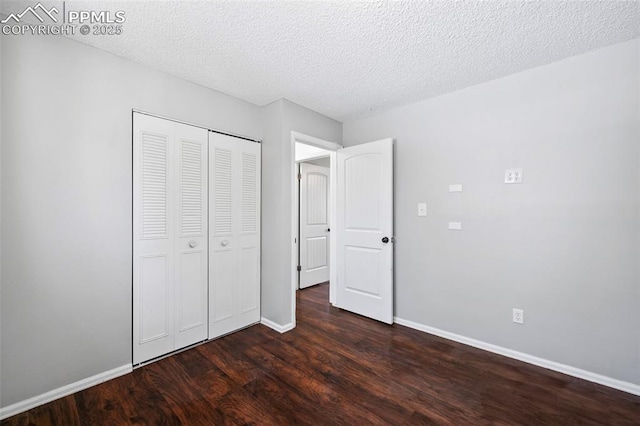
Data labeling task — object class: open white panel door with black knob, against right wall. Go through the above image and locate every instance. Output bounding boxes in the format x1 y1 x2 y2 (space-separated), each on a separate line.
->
335 139 393 324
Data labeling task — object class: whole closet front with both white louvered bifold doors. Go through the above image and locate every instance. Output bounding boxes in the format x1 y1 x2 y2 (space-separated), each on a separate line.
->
133 112 260 365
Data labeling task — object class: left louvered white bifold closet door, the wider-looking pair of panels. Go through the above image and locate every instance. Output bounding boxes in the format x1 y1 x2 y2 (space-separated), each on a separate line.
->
133 113 208 364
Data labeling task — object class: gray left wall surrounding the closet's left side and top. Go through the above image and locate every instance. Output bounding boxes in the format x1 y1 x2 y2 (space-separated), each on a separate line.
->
0 36 262 407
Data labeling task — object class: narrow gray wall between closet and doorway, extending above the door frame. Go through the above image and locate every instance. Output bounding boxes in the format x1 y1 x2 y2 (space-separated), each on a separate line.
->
262 99 342 326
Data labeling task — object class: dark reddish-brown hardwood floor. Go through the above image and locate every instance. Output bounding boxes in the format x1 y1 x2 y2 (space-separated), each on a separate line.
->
2 285 640 426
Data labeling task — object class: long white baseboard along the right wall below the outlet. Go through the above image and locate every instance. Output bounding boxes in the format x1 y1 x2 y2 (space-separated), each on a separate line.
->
393 317 640 396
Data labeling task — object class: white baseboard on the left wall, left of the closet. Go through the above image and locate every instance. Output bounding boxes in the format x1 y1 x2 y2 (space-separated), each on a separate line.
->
0 364 133 420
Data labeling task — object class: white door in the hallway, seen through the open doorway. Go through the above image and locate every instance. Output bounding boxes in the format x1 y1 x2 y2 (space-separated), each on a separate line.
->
300 163 330 288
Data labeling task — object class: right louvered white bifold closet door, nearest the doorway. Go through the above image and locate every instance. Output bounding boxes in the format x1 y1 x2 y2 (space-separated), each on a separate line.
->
209 132 260 339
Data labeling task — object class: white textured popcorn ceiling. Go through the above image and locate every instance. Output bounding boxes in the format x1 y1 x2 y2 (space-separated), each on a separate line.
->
4 1 640 121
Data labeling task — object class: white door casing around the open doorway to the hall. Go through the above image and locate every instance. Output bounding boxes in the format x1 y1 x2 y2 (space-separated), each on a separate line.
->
290 131 342 333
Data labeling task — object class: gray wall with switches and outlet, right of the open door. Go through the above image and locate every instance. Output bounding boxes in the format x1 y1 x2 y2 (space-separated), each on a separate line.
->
344 40 640 384
